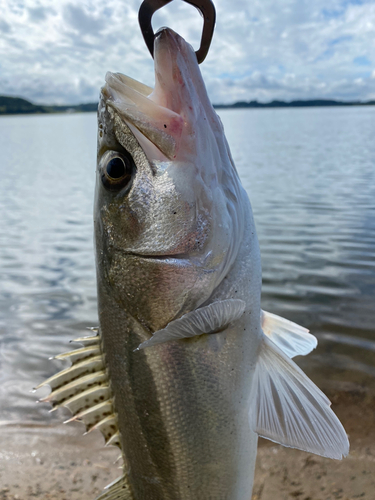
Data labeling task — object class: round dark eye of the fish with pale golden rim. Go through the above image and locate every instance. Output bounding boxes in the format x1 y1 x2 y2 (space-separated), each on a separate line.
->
101 151 135 191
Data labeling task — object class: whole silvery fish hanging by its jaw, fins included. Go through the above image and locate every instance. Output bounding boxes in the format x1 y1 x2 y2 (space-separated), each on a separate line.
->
36 28 349 500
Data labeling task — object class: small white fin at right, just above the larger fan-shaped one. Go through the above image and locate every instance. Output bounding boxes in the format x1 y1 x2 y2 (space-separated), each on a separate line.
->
260 311 318 358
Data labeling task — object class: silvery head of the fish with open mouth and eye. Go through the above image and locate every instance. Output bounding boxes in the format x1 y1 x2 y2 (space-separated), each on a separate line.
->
94 28 247 330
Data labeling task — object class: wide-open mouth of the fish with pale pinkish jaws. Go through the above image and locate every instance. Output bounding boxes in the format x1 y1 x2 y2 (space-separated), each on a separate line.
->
103 28 225 162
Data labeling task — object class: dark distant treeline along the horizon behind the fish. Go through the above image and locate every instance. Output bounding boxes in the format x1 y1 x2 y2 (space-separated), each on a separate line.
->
0 96 375 115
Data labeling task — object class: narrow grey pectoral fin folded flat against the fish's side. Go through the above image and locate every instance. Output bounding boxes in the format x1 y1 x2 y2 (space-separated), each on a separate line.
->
137 299 246 350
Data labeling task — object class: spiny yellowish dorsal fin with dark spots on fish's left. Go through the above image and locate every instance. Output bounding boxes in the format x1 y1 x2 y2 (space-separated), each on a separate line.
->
36 329 121 456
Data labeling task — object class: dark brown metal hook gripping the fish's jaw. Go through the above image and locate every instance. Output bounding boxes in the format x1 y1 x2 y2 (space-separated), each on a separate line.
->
138 0 216 64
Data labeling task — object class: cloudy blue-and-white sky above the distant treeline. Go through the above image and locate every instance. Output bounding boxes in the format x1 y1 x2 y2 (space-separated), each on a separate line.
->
0 0 375 104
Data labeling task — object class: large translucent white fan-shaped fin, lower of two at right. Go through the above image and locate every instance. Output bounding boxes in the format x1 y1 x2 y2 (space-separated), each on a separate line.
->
249 337 349 460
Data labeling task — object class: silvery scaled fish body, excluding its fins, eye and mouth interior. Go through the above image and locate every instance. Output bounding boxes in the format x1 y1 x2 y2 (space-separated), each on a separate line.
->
95 30 261 500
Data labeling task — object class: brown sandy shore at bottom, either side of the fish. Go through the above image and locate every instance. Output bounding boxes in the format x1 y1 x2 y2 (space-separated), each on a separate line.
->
0 390 375 500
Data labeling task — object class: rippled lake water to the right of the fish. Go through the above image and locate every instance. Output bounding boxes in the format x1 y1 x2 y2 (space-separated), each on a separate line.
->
223 108 375 398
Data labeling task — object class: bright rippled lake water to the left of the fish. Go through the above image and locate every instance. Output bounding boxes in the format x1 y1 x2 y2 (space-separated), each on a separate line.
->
0 115 96 420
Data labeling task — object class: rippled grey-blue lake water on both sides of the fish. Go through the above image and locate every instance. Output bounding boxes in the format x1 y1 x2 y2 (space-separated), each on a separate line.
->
0 107 375 424
